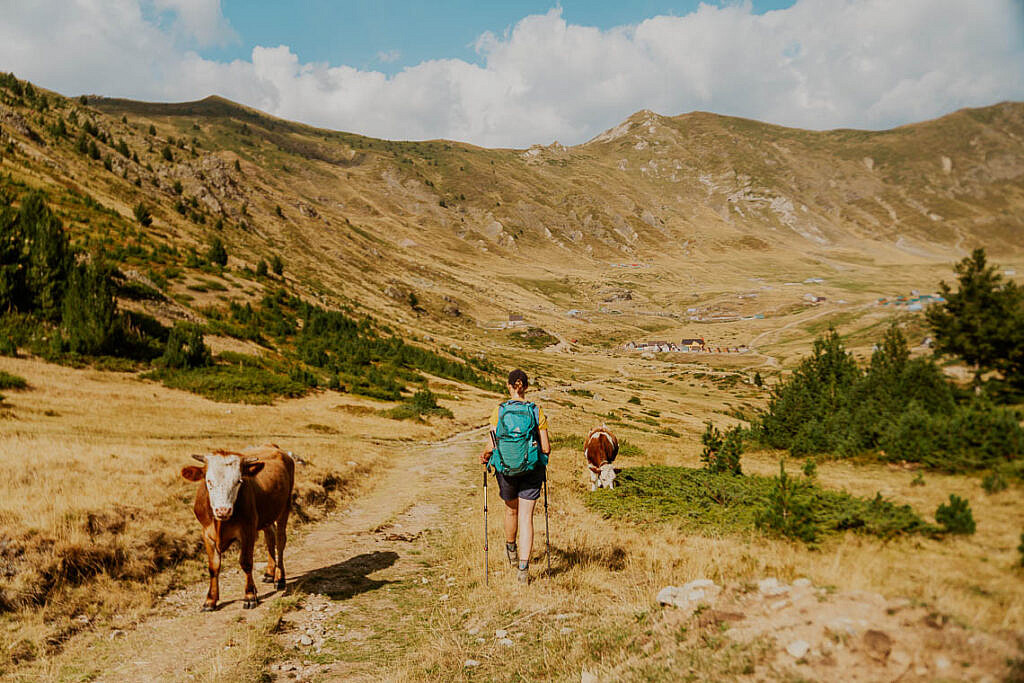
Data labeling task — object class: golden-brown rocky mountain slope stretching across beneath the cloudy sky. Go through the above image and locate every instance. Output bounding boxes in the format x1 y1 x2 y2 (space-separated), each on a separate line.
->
0 77 1024 350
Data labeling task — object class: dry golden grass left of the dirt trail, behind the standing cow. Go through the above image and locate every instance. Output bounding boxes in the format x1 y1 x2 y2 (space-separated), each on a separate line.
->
0 358 487 669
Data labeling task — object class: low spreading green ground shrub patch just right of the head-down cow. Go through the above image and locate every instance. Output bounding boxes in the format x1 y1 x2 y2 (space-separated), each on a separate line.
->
587 465 938 538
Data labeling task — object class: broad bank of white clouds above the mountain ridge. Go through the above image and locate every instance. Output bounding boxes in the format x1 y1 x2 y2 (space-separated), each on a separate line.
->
0 0 1024 146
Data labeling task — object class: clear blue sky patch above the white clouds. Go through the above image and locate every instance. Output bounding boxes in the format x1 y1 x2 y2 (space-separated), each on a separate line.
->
199 0 794 75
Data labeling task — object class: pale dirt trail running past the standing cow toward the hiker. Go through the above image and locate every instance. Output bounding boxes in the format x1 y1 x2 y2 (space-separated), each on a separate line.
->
86 429 483 682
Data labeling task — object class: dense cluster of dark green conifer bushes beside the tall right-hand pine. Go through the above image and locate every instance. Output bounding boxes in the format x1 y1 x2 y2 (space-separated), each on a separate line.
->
752 327 1024 472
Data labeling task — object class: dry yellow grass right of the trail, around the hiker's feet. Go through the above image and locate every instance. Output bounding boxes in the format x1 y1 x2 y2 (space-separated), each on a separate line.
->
389 401 1024 681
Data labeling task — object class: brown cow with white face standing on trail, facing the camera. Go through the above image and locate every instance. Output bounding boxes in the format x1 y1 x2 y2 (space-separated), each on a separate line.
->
181 445 295 611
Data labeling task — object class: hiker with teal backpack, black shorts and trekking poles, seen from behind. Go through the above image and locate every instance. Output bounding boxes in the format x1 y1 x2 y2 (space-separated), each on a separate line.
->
480 370 551 584
